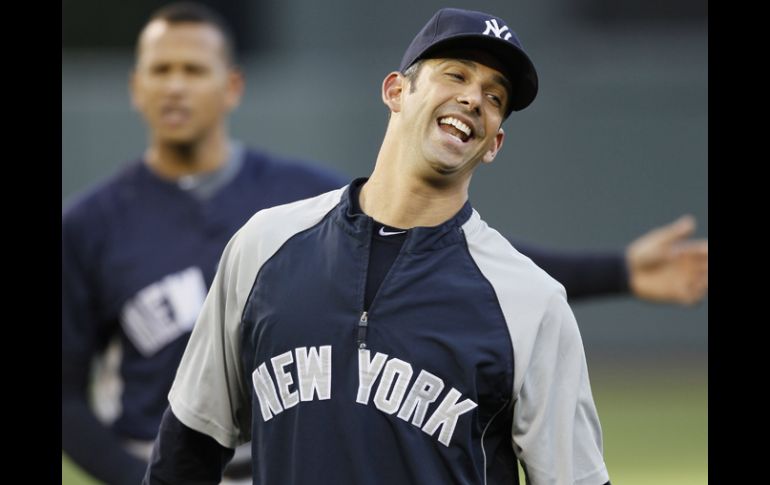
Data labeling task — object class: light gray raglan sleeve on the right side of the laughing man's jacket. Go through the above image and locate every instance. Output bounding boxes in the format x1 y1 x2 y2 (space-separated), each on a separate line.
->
463 212 609 485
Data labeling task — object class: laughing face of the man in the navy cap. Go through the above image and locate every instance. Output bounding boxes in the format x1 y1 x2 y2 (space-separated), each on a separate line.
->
402 58 508 181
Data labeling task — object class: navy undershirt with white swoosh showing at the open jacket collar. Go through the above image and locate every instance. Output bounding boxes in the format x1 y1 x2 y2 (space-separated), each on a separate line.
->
351 184 409 311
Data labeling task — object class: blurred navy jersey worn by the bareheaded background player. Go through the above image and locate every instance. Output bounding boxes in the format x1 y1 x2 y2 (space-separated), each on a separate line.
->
62 144 346 440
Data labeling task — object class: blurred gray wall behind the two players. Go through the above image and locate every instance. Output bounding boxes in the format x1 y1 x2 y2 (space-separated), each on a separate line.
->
62 0 708 364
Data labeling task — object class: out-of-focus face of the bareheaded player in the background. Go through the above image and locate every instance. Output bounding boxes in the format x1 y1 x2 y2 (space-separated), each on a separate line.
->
131 21 241 144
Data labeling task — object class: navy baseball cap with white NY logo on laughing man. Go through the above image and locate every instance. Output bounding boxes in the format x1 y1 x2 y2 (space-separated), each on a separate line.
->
399 8 537 118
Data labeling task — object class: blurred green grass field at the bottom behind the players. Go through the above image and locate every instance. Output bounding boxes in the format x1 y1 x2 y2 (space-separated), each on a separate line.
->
62 360 708 485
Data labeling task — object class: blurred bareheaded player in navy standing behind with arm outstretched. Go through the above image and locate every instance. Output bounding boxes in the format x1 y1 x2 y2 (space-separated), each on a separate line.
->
62 4 707 483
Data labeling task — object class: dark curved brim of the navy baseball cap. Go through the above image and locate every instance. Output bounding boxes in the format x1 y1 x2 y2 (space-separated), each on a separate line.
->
407 34 538 117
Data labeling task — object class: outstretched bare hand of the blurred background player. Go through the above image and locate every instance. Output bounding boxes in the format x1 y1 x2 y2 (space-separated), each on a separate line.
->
626 215 708 305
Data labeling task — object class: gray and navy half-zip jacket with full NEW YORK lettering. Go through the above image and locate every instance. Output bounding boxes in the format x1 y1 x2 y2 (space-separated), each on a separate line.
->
169 181 608 485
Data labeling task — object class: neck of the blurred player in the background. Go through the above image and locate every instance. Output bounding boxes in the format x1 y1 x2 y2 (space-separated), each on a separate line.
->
145 130 230 180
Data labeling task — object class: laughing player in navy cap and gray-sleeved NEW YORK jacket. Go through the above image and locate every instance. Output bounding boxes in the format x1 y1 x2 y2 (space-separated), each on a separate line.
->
144 9 609 485
